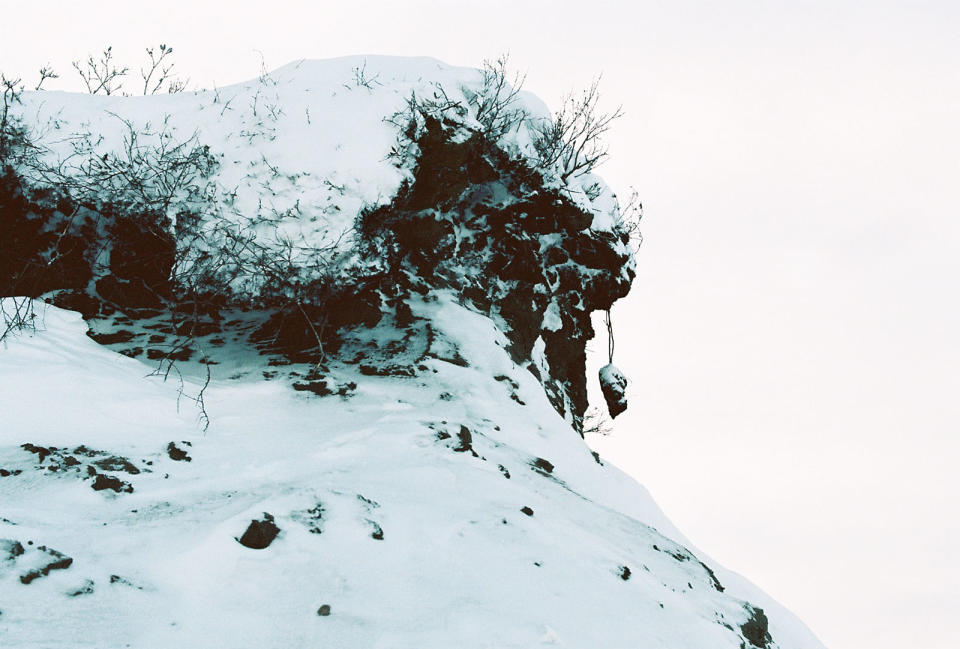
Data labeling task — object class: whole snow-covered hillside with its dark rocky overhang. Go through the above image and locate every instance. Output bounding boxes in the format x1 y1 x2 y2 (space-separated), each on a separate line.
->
0 57 821 649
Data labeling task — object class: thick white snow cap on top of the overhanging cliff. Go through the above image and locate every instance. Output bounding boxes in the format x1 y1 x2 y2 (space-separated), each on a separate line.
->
15 56 628 295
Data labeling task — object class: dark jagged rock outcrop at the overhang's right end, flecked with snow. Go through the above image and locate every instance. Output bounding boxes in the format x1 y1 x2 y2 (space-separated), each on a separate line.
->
358 117 633 431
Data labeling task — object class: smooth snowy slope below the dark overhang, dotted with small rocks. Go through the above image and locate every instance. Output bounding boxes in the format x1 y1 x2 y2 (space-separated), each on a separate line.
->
0 302 822 649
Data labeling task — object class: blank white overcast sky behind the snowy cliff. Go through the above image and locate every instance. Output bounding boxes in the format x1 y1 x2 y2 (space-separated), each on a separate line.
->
0 0 960 649
